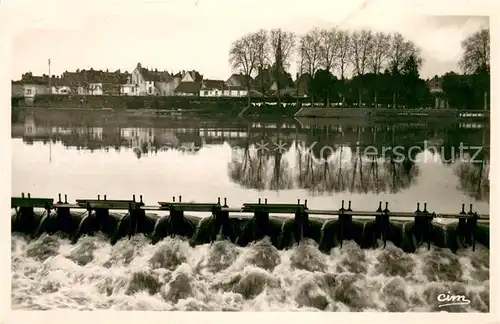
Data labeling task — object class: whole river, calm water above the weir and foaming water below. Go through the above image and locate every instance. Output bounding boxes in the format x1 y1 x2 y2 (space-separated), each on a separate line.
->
12 115 489 312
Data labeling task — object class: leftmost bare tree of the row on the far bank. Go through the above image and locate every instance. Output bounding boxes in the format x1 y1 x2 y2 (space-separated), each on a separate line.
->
229 34 257 106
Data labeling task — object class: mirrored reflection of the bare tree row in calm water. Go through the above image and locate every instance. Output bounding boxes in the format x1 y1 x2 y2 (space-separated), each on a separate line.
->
229 144 418 194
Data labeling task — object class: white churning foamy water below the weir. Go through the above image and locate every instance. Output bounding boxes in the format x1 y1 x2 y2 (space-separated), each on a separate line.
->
12 234 489 312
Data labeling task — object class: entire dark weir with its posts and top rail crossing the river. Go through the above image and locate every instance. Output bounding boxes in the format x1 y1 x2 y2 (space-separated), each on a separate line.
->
11 193 489 253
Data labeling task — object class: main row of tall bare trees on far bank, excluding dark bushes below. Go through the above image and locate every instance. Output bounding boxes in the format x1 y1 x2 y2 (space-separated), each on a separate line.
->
229 28 422 104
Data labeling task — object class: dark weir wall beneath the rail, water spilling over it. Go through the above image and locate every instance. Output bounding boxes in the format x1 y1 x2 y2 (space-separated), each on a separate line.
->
11 208 489 253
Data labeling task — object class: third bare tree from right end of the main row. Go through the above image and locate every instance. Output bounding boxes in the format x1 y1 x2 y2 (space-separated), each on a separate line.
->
350 30 373 107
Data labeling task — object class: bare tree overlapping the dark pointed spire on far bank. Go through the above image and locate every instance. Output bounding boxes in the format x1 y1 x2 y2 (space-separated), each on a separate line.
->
270 29 295 106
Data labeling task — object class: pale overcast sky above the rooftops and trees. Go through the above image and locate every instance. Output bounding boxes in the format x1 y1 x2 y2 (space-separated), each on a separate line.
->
7 0 489 79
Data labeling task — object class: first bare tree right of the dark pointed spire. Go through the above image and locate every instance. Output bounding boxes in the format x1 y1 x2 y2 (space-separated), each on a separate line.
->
299 29 322 106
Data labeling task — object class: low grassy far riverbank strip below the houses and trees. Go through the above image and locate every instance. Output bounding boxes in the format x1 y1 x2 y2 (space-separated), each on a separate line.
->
12 95 490 123
